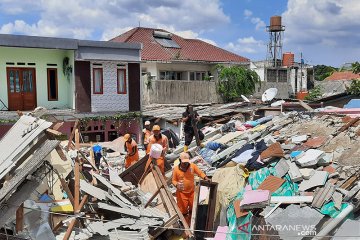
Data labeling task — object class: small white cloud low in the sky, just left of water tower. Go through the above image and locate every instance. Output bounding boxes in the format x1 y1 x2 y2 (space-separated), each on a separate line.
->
225 36 265 54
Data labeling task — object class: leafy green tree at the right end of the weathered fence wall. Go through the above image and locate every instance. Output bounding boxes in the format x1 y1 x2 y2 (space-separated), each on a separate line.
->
217 65 260 102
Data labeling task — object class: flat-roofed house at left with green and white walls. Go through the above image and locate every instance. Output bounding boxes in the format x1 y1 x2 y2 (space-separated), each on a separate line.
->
0 34 141 112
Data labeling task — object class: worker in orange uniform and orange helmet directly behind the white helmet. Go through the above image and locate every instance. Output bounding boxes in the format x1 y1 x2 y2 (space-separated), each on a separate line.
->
145 125 169 176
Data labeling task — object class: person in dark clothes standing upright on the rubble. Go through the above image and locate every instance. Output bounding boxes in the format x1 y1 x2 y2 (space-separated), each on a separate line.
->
182 105 204 152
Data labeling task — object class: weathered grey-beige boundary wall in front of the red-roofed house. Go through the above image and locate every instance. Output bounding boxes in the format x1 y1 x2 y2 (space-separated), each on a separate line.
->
142 76 220 105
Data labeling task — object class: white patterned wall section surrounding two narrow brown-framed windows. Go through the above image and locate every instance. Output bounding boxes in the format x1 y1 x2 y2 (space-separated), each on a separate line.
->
90 61 129 112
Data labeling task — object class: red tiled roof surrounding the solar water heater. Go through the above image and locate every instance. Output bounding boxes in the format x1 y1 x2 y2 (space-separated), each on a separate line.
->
110 27 250 63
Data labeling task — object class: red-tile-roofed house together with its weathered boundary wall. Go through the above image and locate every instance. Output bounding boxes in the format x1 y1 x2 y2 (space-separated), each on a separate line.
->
110 27 250 104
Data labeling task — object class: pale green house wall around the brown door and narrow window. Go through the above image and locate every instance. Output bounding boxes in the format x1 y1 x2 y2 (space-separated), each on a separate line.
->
0 47 75 109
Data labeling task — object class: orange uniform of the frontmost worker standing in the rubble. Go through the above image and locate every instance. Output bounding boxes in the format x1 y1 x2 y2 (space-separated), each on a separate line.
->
172 163 206 215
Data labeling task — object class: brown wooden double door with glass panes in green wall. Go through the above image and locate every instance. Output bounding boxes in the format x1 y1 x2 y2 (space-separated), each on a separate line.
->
7 68 36 111
